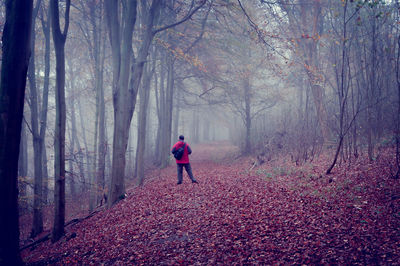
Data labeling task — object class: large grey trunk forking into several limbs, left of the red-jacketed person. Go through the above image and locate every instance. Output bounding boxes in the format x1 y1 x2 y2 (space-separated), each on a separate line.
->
106 0 161 207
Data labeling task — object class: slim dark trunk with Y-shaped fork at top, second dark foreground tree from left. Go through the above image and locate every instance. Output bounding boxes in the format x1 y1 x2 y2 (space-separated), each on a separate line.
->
50 0 71 242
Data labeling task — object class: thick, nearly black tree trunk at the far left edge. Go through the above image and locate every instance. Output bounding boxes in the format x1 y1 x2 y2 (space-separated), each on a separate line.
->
0 0 33 265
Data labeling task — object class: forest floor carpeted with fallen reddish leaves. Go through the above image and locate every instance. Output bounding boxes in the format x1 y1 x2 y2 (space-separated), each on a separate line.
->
22 143 400 265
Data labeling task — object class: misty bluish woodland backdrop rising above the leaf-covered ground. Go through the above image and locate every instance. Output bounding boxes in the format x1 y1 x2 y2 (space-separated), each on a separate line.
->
0 0 400 248
